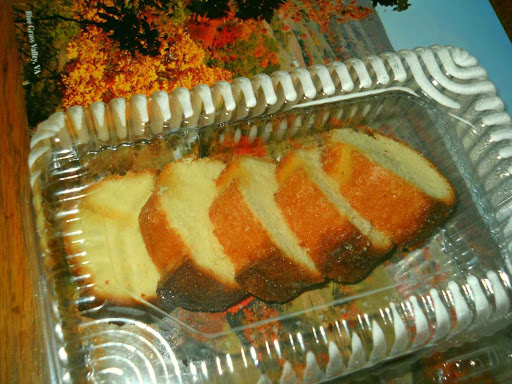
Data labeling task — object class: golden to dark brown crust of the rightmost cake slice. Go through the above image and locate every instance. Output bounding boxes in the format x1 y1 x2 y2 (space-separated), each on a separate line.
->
323 143 451 247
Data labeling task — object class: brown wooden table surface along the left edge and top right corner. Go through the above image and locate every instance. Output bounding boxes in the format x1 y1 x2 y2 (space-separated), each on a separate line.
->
0 0 512 384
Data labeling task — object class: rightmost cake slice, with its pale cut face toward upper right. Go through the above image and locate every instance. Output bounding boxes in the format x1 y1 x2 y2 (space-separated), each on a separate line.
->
323 129 455 249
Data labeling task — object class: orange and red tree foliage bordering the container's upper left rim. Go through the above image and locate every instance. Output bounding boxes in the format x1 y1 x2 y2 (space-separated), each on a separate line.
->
60 0 278 108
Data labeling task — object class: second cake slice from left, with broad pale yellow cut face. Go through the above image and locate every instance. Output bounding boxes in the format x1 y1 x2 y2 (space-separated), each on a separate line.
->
139 158 247 311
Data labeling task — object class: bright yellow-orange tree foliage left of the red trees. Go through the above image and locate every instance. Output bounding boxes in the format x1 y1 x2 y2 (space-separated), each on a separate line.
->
61 11 232 108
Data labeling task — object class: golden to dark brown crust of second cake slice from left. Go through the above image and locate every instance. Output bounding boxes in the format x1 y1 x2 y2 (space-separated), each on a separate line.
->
139 185 247 311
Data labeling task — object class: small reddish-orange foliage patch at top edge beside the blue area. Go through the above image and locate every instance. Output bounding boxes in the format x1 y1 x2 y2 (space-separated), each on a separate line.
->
279 0 372 30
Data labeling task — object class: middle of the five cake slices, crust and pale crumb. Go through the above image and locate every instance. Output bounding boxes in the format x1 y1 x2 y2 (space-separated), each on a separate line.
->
210 156 323 302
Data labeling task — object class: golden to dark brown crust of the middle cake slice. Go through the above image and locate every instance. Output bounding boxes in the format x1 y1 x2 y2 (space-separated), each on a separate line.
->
210 161 321 301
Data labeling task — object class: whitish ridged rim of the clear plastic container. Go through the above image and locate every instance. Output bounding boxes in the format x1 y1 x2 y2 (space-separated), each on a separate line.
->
28 45 512 383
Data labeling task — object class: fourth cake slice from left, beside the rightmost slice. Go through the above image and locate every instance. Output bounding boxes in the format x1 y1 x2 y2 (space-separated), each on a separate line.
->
275 147 393 283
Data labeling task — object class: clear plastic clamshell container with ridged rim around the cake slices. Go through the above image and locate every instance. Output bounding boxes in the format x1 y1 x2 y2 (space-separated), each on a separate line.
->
24 46 512 383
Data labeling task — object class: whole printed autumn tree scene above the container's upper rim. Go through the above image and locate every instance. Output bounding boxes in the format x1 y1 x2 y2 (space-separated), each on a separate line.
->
10 0 372 125
